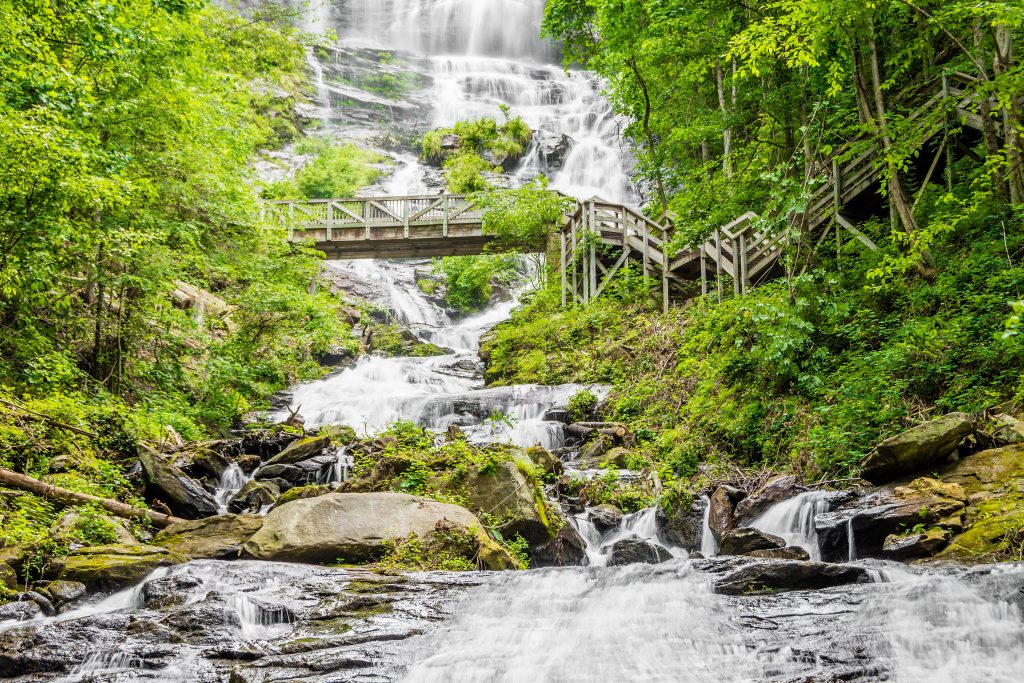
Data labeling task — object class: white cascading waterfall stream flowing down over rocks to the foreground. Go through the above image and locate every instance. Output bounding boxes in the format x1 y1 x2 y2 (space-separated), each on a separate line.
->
0 0 1024 683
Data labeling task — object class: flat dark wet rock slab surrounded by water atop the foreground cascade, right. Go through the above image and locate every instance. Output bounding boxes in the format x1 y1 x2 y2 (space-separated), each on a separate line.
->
712 560 870 595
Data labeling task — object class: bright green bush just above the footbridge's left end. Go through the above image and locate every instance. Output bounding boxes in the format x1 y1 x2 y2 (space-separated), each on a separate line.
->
263 137 385 199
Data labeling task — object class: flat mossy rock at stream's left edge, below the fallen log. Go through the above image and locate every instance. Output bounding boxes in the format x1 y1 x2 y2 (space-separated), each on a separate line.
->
57 545 188 589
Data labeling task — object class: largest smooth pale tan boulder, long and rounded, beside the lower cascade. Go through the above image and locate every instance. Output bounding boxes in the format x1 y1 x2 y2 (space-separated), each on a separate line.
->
245 493 515 569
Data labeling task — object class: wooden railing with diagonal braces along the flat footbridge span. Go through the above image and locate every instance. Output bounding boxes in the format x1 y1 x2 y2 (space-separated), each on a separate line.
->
264 195 483 242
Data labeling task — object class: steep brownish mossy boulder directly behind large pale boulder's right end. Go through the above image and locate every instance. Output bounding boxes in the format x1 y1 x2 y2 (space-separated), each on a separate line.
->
466 462 553 546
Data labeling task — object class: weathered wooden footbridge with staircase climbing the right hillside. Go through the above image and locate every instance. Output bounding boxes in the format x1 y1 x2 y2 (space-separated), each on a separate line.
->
265 72 981 309
